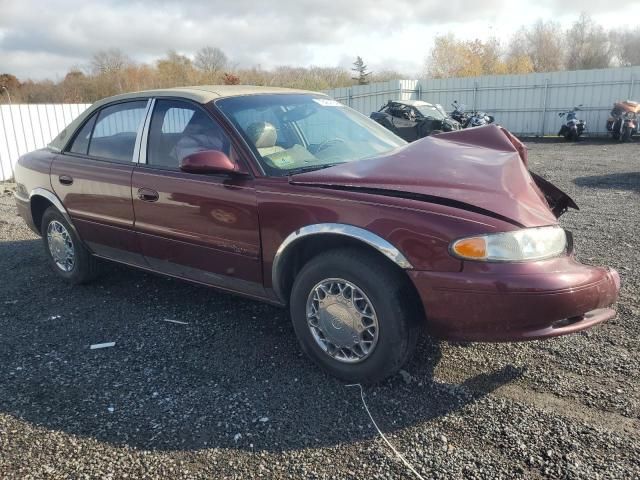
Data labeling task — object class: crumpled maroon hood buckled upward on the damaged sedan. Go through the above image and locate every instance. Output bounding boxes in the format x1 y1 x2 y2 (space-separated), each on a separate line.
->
290 125 557 227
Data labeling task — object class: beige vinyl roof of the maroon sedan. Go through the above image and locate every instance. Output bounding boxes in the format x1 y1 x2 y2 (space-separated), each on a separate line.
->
48 85 324 151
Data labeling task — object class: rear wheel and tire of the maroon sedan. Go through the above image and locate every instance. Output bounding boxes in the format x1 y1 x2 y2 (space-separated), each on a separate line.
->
40 207 98 285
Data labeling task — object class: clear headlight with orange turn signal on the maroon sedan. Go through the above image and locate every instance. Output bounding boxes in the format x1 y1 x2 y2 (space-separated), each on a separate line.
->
450 226 567 262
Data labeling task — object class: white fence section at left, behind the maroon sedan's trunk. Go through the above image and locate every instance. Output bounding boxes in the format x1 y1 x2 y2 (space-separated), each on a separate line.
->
0 103 89 180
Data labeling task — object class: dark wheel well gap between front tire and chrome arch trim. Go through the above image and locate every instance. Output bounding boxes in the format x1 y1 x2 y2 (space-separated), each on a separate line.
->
279 233 424 318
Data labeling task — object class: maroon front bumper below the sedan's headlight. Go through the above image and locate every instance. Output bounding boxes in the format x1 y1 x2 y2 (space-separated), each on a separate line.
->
408 256 620 342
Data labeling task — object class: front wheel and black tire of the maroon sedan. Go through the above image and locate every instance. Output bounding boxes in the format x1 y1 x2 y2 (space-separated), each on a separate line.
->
290 249 421 383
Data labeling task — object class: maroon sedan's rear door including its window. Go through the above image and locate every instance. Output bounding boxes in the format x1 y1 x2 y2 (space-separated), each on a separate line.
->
51 99 151 265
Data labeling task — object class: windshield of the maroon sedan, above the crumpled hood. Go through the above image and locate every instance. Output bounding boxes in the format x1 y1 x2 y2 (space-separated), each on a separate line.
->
215 94 406 176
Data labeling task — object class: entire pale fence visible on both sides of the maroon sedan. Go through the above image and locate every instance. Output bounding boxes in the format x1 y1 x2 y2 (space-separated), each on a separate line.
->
0 67 640 180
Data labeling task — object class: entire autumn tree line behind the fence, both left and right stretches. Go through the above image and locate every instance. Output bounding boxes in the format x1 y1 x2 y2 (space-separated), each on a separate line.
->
0 14 640 103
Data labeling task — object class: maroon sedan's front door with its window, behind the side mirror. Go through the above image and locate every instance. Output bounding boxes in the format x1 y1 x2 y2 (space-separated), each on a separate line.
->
132 99 264 297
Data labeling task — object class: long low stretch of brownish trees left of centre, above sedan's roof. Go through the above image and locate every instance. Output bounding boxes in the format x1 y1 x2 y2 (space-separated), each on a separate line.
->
0 47 403 103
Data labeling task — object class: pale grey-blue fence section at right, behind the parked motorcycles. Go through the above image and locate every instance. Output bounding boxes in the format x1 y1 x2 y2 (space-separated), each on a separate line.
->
325 67 640 136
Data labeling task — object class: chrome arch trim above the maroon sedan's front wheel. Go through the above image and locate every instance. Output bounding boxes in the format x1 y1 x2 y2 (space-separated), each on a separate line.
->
271 223 413 303
